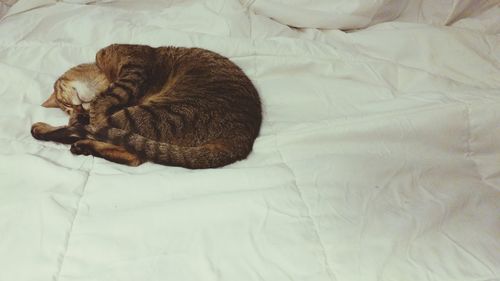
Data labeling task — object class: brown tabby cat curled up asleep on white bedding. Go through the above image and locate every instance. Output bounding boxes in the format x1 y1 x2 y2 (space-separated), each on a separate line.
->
31 44 262 169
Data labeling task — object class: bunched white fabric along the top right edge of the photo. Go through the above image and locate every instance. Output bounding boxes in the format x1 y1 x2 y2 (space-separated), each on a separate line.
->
240 0 500 30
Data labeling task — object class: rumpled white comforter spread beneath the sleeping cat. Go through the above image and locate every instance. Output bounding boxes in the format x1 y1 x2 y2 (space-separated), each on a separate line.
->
0 0 500 281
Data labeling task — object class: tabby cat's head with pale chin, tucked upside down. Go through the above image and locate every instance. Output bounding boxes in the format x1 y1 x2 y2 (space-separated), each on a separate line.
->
42 64 110 115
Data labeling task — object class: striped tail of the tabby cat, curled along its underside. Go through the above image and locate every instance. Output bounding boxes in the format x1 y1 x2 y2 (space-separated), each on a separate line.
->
93 127 252 169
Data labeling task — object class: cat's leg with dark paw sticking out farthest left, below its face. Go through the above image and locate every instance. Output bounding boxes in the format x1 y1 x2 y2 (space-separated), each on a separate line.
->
31 122 87 144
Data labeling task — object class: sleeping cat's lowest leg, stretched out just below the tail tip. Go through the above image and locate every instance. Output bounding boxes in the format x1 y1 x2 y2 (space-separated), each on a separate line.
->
71 139 144 166
